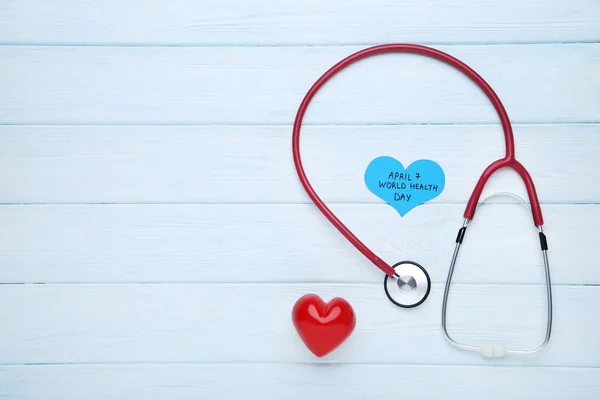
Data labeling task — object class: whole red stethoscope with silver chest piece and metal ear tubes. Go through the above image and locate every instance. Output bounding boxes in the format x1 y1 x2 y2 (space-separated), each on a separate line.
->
292 44 552 357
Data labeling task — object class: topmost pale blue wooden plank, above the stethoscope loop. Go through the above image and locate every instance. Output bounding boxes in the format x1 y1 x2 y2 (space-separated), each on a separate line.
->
0 0 600 45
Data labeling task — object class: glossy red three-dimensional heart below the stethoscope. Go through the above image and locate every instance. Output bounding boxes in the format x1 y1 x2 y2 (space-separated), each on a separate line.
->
292 293 356 357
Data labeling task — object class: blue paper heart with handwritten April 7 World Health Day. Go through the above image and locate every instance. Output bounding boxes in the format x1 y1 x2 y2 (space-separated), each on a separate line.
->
365 156 446 216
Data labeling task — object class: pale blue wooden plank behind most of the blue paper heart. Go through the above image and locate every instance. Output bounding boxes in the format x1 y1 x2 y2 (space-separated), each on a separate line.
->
0 124 600 204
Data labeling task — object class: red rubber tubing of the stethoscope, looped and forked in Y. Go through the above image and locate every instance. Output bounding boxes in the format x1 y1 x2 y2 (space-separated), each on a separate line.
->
292 44 544 277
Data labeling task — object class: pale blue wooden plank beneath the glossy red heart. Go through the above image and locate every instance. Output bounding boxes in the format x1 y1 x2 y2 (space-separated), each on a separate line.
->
0 284 600 367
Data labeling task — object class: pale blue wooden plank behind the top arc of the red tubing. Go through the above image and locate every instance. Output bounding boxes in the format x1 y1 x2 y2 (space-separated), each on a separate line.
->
0 43 600 124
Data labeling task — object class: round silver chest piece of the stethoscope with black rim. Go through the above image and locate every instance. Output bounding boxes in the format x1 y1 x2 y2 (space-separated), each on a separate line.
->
383 261 431 308
